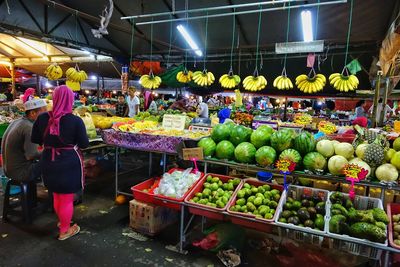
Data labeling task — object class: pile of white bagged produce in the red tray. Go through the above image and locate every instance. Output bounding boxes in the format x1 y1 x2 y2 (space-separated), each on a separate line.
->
154 168 201 198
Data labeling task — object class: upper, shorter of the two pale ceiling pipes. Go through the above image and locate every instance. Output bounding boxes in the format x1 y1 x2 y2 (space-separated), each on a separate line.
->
121 0 304 20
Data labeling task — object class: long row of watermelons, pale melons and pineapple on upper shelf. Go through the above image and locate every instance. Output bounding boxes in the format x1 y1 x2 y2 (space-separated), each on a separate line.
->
198 123 400 183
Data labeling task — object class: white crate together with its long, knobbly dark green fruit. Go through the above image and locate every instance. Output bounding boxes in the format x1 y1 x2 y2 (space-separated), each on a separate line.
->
327 192 389 259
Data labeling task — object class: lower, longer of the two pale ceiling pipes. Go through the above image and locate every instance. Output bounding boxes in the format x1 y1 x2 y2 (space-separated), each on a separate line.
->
135 0 347 26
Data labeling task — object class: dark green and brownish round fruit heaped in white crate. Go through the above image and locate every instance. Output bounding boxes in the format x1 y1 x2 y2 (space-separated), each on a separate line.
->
278 194 326 231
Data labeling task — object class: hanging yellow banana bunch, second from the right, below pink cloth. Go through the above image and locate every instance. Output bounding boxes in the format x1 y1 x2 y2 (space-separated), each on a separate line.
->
296 68 326 94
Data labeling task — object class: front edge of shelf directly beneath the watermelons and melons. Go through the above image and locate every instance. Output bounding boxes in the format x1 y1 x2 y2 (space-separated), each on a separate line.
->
199 158 400 200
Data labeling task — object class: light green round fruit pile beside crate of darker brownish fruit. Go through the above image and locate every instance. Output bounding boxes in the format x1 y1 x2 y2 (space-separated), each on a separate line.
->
229 183 282 220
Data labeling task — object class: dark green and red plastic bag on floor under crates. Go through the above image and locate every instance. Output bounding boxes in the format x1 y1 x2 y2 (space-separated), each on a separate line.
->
193 223 245 252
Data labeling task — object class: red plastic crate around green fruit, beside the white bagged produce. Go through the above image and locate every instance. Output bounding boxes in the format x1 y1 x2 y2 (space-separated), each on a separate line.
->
185 173 243 220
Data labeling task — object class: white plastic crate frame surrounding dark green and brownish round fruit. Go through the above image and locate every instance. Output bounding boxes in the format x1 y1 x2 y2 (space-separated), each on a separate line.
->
275 185 329 245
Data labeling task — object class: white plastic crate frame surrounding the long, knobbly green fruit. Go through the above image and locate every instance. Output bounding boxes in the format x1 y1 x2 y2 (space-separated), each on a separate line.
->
325 192 388 259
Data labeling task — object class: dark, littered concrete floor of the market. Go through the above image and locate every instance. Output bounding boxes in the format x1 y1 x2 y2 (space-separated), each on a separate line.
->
0 153 372 267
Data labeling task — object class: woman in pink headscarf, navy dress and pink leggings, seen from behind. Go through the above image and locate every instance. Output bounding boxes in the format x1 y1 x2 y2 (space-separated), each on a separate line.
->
32 85 89 240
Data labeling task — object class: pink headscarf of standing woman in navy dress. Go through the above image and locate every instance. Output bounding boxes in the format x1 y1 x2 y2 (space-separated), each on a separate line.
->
49 85 74 136
